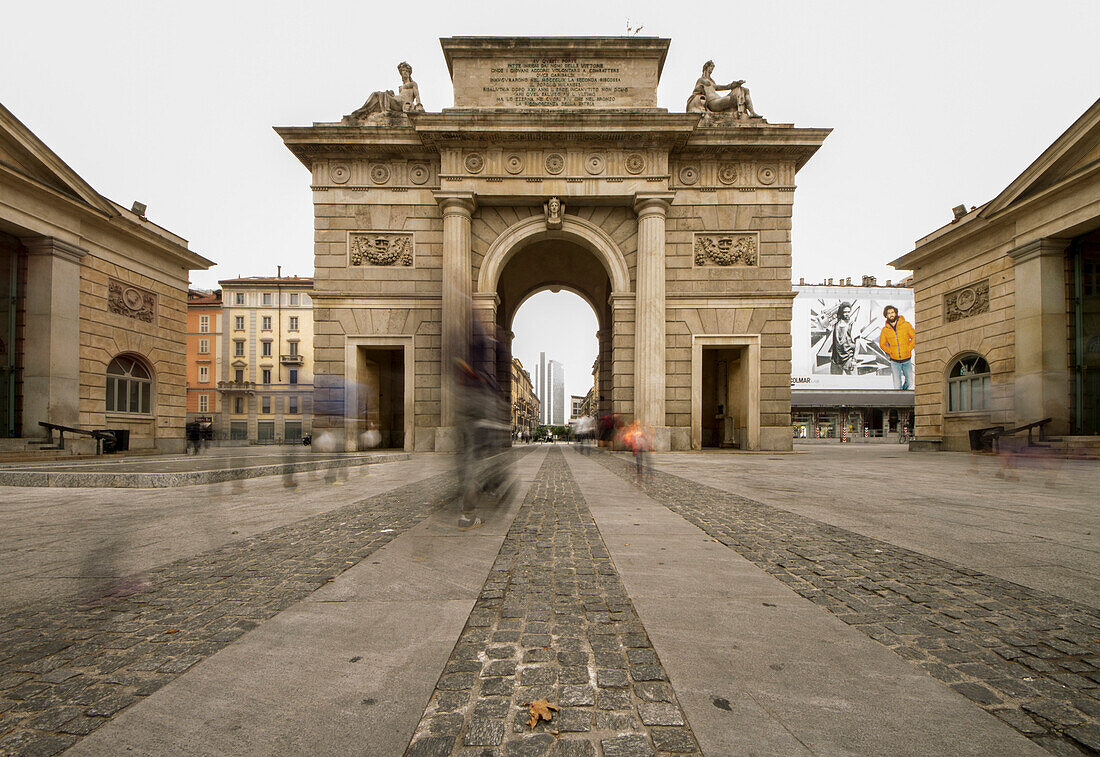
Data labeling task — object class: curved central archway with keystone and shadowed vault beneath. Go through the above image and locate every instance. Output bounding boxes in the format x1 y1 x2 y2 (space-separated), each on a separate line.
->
474 215 634 426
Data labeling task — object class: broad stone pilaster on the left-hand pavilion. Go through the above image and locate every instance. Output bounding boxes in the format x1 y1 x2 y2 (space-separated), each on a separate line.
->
22 237 85 437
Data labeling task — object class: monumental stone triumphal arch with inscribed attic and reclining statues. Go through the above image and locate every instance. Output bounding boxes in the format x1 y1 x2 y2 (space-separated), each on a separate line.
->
276 37 828 451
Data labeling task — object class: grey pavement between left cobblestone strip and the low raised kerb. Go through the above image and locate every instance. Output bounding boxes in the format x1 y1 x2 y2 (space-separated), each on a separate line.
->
0 456 453 613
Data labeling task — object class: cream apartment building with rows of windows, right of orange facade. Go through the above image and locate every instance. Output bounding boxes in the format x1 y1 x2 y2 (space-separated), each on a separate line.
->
216 276 314 445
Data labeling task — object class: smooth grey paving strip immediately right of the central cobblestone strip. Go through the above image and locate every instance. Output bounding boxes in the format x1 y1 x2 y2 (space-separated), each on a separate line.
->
567 454 1045 755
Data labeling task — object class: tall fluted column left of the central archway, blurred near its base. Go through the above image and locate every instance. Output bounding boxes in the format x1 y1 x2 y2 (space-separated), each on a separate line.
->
435 191 477 452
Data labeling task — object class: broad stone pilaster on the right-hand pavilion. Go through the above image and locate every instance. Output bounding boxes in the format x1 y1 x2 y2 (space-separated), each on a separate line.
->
1009 239 1070 435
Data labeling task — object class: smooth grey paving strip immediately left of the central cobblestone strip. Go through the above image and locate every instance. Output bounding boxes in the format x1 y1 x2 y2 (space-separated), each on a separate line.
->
67 452 543 756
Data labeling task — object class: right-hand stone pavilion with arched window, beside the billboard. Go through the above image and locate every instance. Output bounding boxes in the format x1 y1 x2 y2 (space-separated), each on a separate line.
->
891 100 1100 450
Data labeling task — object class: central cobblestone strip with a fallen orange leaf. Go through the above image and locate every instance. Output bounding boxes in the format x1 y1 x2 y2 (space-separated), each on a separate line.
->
406 449 700 757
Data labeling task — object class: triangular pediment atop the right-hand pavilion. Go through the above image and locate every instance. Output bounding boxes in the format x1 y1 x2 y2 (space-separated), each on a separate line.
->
981 100 1100 217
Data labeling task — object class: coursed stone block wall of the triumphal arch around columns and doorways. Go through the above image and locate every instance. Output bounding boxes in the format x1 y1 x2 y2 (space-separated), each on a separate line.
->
305 151 795 450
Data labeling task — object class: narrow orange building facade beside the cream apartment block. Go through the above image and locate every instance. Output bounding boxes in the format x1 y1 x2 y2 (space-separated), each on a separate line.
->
187 289 223 432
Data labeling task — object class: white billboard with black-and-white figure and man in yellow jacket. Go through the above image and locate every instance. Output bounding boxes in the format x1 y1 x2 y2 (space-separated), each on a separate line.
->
791 286 914 390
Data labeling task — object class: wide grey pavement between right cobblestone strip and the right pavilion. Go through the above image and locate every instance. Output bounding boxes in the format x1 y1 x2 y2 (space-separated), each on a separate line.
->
652 445 1100 607
